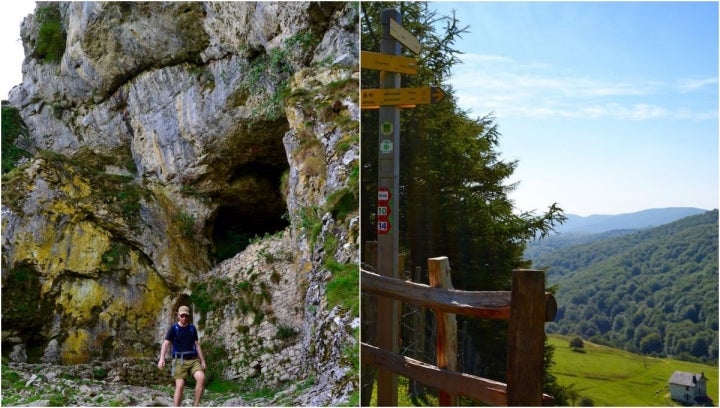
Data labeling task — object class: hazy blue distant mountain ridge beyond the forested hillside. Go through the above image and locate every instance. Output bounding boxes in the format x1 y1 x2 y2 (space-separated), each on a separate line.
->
556 207 708 234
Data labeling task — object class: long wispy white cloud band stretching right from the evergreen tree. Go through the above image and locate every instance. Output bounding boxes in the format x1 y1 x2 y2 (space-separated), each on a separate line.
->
450 54 717 121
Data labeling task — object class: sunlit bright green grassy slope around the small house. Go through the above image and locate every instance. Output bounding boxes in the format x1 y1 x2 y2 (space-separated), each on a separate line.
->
548 335 718 406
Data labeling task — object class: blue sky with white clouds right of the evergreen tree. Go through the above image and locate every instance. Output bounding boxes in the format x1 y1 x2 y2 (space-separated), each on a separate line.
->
429 2 718 215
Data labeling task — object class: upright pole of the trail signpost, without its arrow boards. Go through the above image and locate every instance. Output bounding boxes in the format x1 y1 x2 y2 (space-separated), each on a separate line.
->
376 9 401 407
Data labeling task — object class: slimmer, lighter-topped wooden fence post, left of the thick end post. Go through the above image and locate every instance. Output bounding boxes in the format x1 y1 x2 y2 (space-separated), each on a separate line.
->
428 256 457 407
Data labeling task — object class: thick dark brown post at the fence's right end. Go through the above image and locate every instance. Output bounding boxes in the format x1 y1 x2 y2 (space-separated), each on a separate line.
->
507 269 545 406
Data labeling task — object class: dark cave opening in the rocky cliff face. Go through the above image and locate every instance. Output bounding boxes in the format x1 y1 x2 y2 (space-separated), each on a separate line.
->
212 161 290 262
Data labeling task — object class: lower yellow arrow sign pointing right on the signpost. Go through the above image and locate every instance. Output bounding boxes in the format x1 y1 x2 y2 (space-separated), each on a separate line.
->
360 86 445 109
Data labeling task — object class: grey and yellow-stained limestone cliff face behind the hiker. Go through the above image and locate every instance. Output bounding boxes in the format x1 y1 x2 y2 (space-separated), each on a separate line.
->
2 2 359 404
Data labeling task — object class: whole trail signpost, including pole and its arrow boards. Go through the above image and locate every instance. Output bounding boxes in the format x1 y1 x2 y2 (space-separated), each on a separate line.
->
360 9 445 406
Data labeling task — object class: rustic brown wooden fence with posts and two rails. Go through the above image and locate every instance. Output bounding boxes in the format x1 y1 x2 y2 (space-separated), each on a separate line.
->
361 257 557 406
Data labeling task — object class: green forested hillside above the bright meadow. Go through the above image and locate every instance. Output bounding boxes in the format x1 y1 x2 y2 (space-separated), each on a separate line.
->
533 210 718 363
